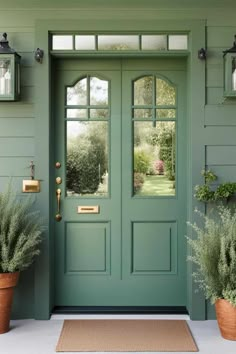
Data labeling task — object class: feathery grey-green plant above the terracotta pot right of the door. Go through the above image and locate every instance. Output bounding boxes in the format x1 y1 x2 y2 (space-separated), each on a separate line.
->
187 205 236 306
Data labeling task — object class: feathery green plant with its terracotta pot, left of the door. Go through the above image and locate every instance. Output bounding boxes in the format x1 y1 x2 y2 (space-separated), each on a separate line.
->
0 185 42 334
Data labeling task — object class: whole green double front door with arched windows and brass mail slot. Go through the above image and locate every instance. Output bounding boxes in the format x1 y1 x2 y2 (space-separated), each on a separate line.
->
52 59 187 306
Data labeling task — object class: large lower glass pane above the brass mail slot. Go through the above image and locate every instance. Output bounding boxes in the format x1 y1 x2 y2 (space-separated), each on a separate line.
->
66 121 109 197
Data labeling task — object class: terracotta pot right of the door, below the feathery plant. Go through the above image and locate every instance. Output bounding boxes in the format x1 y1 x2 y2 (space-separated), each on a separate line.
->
215 299 236 340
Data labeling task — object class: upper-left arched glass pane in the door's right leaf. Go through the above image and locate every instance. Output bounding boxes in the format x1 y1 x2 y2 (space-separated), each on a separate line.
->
134 76 153 106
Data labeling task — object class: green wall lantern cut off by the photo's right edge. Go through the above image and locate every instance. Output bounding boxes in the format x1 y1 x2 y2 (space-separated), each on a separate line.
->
223 35 236 97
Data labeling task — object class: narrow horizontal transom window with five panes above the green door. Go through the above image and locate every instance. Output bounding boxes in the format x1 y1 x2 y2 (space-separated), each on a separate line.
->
51 33 188 52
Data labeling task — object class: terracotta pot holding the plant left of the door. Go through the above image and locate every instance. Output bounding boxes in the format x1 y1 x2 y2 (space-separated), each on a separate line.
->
0 272 20 334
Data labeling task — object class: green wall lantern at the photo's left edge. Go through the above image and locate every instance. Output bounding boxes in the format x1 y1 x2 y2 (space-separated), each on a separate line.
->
0 33 21 101
